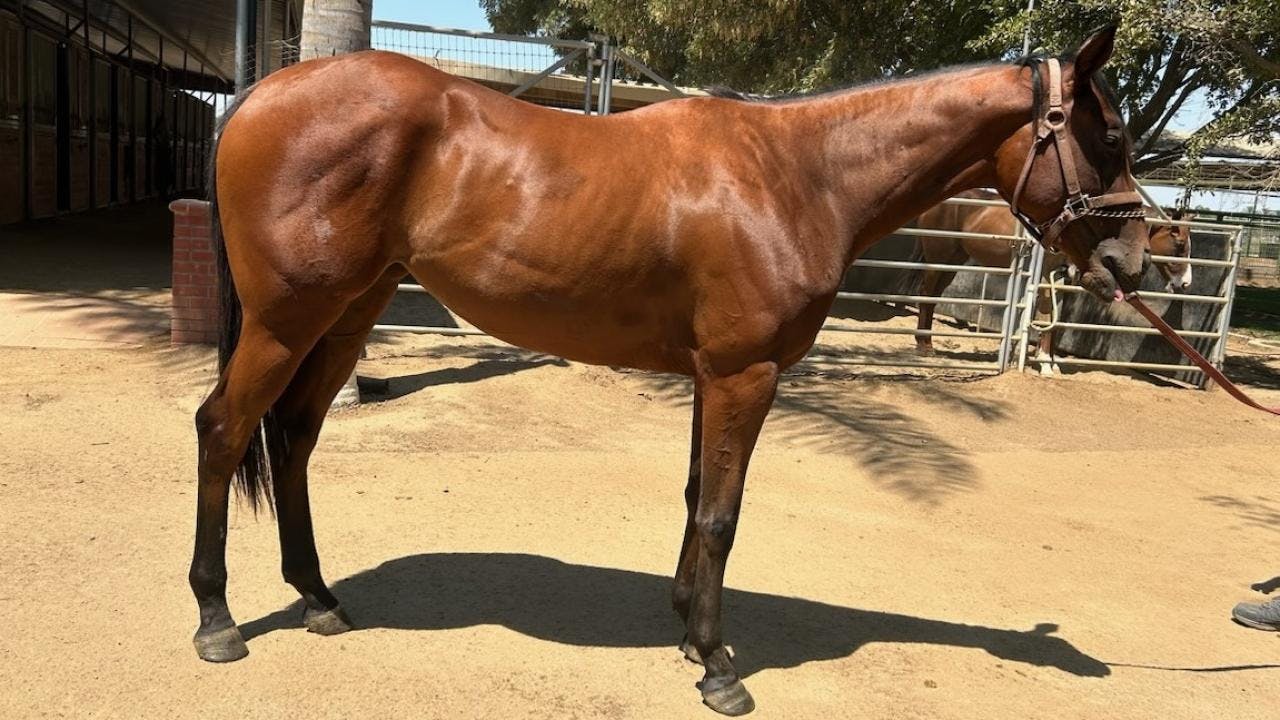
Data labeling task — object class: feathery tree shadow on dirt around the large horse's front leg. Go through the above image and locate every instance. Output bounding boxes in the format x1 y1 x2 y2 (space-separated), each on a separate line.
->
629 368 1009 505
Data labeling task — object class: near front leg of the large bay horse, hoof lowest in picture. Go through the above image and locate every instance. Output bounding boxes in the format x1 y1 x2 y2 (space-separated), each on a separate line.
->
689 363 778 715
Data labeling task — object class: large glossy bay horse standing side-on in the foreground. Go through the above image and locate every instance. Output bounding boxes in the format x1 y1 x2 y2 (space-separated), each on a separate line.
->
189 28 1148 715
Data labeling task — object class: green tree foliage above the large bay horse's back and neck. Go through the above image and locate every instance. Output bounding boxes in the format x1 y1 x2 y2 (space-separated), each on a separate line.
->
480 0 1280 178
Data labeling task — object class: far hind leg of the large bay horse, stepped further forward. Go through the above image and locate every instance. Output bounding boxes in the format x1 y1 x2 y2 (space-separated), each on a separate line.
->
271 270 404 635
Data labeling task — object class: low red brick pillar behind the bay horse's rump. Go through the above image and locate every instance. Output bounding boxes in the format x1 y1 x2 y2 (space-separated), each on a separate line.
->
169 200 218 345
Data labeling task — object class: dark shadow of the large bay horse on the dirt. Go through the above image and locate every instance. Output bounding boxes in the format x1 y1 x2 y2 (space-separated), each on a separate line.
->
241 553 1111 678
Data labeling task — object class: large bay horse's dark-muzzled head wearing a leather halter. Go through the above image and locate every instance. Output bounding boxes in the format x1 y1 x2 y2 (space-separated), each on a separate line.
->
996 28 1151 300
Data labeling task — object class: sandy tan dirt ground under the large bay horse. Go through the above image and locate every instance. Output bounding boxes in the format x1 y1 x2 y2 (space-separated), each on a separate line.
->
0 338 1280 720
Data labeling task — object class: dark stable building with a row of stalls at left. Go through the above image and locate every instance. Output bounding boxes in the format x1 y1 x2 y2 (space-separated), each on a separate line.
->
0 0 301 224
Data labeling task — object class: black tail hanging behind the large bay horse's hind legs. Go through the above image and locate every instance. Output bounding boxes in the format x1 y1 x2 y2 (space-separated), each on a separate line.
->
207 88 277 512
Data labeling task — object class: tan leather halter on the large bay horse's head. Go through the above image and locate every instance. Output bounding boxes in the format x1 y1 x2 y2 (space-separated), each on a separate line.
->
1009 58 1146 252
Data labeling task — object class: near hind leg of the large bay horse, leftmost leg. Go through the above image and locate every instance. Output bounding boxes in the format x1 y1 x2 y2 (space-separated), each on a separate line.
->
189 316 323 662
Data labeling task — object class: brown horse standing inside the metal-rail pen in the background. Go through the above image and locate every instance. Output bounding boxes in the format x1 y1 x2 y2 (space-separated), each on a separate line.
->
911 190 1192 366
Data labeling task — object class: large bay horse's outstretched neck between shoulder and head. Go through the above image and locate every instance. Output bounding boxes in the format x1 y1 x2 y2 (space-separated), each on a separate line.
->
795 65 1032 264
